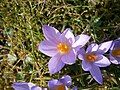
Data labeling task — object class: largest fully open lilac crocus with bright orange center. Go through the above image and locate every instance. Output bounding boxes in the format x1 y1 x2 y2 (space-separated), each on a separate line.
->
38 25 90 74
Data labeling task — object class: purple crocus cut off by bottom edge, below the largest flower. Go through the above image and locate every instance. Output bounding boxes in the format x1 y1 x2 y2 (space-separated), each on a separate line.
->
48 75 72 90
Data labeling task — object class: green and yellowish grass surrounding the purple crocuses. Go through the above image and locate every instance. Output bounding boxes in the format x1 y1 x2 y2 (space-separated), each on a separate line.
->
0 0 120 90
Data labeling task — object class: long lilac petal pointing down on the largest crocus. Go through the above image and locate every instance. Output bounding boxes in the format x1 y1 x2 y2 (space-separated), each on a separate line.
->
48 53 65 74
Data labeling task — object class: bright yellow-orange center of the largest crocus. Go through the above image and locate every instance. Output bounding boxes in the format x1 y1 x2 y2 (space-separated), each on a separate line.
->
57 43 70 54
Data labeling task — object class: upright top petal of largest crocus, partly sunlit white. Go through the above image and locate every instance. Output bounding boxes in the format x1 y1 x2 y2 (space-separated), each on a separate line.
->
61 28 75 44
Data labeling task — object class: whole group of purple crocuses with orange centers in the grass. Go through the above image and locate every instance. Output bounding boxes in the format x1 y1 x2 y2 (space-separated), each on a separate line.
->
13 25 120 90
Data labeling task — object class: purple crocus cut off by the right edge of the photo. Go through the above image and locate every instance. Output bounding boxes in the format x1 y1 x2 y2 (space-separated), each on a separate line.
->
110 38 120 64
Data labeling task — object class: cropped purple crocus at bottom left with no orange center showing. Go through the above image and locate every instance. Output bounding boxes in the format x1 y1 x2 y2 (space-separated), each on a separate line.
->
12 82 43 90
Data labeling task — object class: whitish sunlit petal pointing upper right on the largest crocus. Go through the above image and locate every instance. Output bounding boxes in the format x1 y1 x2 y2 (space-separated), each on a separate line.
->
72 34 90 47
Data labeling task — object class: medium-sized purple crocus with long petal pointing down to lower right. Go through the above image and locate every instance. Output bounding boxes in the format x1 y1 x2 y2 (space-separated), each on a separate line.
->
78 41 112 84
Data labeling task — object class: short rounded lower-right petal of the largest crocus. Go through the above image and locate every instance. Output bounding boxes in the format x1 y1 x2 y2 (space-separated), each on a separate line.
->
61 50 76 65
